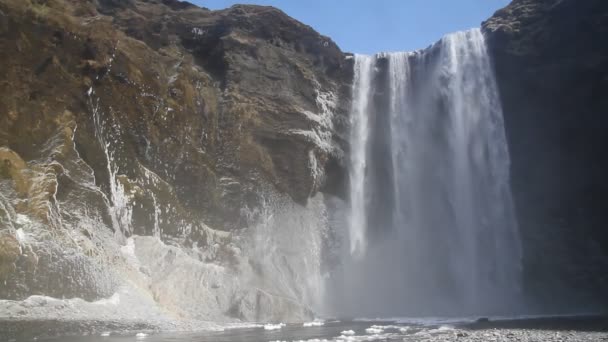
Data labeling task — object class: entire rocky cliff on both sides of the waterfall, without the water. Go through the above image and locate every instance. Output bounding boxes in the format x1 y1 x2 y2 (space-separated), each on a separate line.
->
0 0 608 328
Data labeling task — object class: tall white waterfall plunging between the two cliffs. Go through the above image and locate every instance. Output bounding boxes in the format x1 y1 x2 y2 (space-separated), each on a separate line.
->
335 29 521 315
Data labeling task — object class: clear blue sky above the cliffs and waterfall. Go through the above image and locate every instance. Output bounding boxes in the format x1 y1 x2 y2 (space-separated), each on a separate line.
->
188 0 510 54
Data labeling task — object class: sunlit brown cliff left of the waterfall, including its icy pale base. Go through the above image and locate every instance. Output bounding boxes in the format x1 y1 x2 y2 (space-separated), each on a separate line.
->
0 0 352 320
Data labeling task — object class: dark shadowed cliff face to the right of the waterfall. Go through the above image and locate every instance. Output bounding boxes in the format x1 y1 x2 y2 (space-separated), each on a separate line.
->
483 0 608 309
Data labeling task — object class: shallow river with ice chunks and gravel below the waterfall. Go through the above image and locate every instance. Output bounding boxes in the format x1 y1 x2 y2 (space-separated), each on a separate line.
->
0 316 608 342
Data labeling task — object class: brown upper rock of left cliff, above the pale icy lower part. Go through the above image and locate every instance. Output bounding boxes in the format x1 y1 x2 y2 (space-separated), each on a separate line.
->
0 0 349 235
